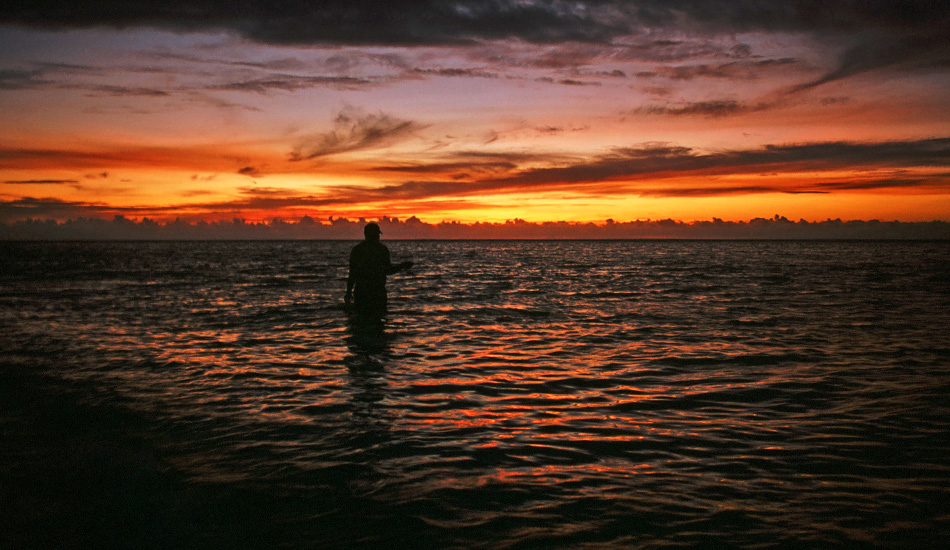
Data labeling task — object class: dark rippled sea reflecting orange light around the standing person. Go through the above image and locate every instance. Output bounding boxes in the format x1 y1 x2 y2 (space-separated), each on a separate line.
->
0 241 950 549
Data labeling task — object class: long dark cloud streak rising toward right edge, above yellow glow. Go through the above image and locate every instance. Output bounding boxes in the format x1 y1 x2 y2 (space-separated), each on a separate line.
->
352 138 950 200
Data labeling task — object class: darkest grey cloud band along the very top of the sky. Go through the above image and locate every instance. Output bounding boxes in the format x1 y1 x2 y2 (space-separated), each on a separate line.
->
0 0 950 45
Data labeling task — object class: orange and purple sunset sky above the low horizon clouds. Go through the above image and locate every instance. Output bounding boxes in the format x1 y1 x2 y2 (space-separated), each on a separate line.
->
0 0 950 229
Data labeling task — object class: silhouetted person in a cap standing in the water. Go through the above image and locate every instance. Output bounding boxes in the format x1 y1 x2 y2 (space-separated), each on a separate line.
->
344 222 412 315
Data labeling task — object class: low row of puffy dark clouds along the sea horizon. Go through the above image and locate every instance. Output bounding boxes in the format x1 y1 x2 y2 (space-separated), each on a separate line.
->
0 215 950 240
